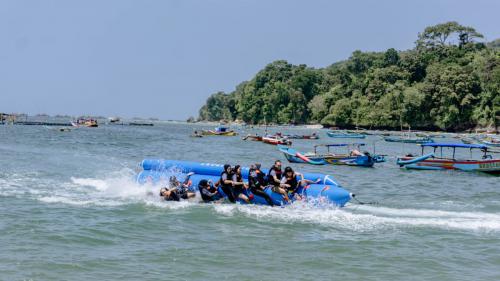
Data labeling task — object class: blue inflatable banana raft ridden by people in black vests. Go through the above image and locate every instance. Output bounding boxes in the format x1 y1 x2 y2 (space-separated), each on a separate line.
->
136 159 354 207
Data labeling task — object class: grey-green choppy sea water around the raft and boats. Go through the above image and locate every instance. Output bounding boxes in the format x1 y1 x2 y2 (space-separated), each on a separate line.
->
0 123 500 280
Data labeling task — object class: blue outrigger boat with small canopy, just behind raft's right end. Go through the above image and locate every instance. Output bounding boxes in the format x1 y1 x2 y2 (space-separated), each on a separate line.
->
279 143 385 167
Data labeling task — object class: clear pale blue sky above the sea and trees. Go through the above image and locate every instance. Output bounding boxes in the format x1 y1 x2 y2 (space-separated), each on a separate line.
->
0 0 500 119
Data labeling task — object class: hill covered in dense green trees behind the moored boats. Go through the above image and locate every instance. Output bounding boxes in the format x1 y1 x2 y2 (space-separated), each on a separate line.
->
199 22 500 130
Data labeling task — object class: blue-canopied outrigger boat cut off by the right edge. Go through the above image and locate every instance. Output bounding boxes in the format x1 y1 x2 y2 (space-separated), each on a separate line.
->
396 143 500 174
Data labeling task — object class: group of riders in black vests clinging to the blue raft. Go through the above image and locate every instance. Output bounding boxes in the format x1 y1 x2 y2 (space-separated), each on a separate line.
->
160 160 320 206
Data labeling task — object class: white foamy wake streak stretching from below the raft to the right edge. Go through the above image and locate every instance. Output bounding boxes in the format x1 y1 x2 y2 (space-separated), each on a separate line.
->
214 201 500 232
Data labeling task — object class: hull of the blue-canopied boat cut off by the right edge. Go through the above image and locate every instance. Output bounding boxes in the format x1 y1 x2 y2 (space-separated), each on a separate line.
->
397 157 500 174
